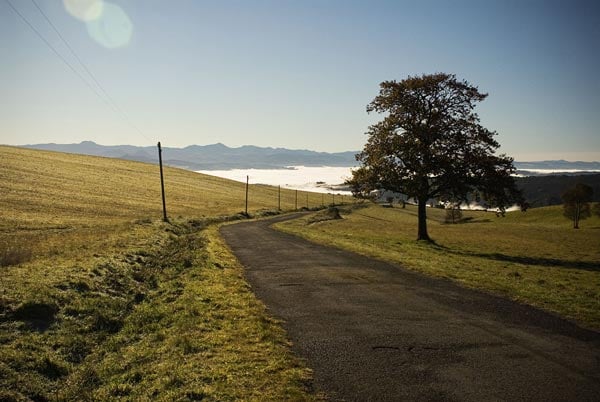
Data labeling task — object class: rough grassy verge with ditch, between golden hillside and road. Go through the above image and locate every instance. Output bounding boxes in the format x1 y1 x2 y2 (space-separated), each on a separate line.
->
0 218 312 401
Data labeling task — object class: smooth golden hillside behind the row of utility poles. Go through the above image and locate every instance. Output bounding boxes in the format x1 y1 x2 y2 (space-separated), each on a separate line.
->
0 146 322 227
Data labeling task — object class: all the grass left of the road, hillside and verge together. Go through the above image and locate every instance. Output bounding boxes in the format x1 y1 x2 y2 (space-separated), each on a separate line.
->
0 146 321 400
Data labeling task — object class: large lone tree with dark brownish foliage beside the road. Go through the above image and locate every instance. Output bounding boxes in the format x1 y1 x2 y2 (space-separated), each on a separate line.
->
348 73 521 240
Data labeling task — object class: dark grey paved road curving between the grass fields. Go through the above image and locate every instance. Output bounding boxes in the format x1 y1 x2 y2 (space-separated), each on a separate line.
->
221 217 600 402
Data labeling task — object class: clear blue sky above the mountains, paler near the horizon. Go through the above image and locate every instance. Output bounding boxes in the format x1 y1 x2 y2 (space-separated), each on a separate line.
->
0 0 600 161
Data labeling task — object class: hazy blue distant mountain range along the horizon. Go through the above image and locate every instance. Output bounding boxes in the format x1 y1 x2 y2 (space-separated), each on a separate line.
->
17 141 600 176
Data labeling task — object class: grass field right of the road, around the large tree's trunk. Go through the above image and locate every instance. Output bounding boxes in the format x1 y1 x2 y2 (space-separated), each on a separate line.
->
276 205 600 330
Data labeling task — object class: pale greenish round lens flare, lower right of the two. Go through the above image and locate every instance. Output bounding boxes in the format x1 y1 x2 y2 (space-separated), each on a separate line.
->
86 2 133 49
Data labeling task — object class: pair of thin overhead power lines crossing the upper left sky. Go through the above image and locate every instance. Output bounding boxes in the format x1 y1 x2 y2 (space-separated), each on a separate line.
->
6 0 151 141
